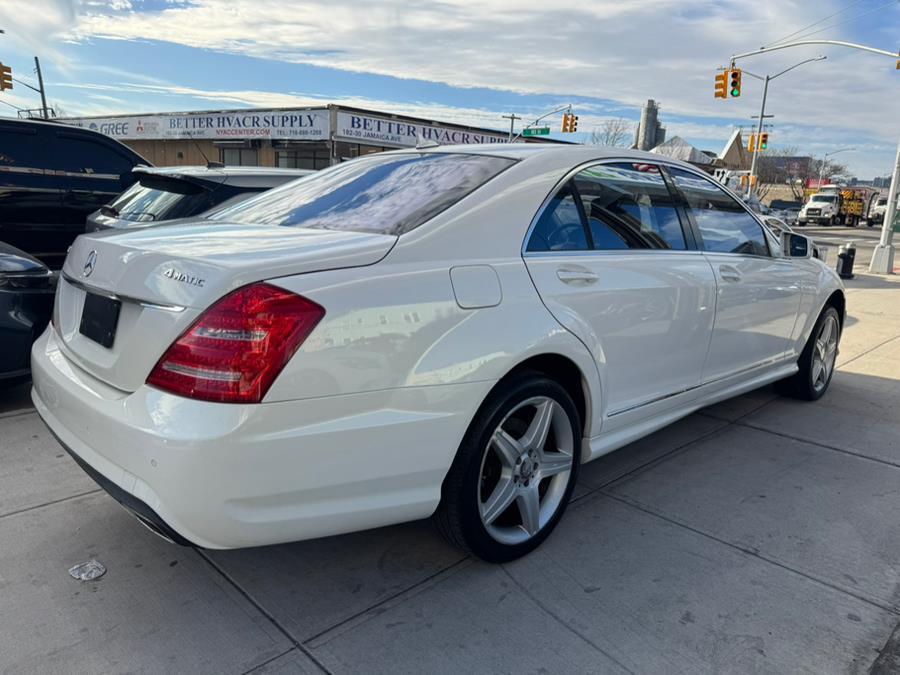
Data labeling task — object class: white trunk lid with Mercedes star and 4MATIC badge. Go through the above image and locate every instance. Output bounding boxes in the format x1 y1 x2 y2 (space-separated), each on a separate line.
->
54 221 397 391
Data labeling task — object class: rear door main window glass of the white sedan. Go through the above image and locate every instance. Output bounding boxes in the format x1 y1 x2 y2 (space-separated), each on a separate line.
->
574 162 687 250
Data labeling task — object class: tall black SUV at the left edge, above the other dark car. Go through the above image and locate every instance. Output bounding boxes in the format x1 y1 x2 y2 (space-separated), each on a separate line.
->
0 118 147 269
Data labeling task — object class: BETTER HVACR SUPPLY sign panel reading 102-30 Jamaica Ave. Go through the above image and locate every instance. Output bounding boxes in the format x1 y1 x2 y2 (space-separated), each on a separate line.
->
334 111 508 147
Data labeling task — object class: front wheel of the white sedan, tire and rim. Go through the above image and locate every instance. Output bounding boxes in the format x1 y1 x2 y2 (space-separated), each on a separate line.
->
777 305 841 401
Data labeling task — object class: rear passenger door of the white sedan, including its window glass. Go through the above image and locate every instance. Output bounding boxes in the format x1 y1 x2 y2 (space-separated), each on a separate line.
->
524 162 715 415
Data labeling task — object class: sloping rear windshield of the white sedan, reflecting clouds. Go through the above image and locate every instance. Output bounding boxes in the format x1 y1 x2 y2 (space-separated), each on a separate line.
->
212 153 514 235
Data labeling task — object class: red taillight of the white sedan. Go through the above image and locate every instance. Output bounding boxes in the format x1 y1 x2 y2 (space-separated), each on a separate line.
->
147 283 325 403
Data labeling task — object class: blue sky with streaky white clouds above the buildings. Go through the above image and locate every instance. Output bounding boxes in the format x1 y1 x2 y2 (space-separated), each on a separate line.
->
0 0 900 178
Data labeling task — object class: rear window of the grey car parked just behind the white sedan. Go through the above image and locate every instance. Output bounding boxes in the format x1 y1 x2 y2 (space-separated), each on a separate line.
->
105 176 213 223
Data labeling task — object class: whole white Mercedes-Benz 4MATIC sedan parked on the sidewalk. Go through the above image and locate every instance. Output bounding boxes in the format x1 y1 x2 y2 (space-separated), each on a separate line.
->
32 145 845 561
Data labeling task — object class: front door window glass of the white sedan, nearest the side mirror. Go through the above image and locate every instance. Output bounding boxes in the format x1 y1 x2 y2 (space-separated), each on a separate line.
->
668 167 770 257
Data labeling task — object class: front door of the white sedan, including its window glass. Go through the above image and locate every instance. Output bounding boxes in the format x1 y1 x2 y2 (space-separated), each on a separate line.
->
668 167 802 382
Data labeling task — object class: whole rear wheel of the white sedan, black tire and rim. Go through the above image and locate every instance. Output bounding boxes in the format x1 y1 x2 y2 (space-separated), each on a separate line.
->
433 371 583 563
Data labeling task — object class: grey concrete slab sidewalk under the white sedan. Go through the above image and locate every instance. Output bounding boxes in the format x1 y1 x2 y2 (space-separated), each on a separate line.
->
0 276 900 674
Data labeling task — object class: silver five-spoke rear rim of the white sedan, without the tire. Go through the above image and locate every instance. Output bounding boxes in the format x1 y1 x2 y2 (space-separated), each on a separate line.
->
478 396 575 544
